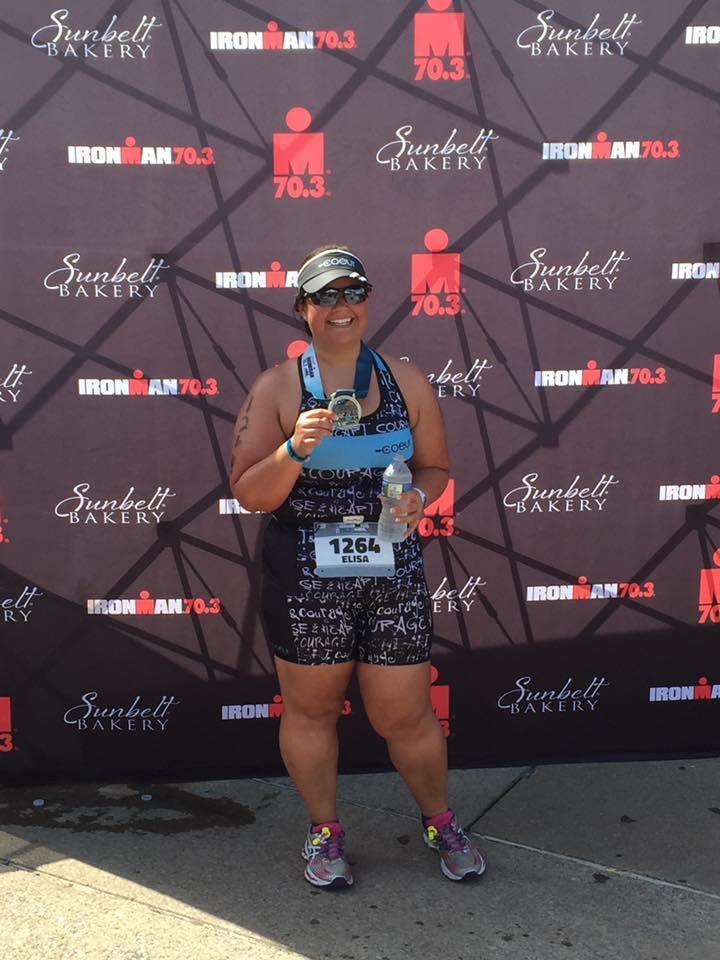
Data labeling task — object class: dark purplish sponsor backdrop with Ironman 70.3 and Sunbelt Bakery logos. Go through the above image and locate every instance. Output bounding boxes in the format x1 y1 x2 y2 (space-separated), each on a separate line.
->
0 0 720 781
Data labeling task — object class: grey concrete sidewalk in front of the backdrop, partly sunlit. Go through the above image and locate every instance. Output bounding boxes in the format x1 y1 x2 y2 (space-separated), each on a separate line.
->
0 759 720 960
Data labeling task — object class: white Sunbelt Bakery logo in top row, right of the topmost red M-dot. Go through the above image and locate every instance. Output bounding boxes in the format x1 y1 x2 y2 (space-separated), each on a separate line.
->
515 10 642 57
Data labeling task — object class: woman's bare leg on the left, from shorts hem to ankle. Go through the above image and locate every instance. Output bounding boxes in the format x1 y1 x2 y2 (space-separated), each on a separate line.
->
275 657 354 823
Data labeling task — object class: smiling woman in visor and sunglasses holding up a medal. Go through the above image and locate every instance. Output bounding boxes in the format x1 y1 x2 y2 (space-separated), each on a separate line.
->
231 245 485 887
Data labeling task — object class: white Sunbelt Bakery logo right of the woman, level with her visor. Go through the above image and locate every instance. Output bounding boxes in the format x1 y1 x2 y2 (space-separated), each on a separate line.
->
510 247 630 293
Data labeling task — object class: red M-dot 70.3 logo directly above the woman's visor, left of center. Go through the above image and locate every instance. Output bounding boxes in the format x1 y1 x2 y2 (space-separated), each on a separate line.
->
273 107 331 200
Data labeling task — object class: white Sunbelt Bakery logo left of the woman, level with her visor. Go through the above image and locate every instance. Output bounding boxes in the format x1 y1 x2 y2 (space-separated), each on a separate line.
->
43 252 170 300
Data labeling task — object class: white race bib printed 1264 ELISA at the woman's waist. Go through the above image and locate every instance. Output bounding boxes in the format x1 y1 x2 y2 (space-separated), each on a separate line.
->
315 523 395 577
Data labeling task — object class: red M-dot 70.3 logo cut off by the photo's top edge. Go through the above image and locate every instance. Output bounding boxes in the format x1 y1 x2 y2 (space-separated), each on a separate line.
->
413 0 470 82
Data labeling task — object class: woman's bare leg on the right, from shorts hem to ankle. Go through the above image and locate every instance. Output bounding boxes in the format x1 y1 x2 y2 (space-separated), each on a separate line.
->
358 662 448 817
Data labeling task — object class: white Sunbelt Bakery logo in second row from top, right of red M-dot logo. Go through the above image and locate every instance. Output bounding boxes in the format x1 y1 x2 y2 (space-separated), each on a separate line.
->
375 123 500 173
